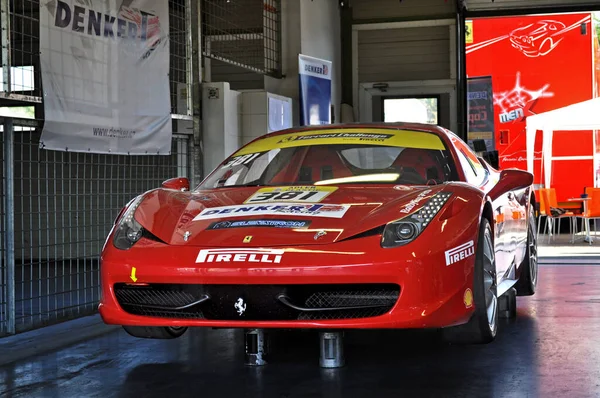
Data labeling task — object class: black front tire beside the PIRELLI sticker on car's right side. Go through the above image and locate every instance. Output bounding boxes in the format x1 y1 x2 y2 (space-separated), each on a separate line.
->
442 218 498 344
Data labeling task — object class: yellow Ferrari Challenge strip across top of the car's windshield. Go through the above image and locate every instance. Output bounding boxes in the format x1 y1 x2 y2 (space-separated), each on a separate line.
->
233 128 445 156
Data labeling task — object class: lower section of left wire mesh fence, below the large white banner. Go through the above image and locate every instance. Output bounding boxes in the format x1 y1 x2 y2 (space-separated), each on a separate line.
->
14 126 188 332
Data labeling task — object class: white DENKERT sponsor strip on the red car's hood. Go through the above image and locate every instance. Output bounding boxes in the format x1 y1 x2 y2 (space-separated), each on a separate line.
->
194 203 350 221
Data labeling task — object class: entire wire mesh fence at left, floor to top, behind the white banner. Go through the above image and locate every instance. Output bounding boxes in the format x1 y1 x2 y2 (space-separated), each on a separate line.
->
0 0 197 335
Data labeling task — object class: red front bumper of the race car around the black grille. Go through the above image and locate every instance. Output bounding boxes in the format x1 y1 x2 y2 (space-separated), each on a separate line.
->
99 236 475 329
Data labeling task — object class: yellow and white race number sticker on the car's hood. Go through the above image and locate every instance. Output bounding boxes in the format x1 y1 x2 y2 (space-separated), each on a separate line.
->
244 186 337 204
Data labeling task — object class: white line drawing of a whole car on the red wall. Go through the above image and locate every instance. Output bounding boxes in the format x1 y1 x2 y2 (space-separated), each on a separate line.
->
509 20 568 57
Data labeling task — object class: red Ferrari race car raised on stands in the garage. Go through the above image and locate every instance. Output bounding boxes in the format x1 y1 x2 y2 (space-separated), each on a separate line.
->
99 123 538 343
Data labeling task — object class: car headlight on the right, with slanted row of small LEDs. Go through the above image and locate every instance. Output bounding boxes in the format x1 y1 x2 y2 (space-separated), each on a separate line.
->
381 192 452 248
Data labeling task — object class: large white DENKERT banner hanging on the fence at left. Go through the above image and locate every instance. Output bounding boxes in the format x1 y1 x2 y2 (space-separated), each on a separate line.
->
40 0 172 155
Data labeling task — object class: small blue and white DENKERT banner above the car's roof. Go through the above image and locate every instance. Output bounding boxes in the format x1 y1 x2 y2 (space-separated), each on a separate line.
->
298 54 331 126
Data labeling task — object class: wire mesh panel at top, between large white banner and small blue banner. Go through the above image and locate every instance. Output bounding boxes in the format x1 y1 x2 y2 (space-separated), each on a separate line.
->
201 0 281 77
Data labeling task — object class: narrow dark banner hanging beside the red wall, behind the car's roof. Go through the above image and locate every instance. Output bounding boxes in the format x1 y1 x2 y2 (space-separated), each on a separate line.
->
467 76 496 151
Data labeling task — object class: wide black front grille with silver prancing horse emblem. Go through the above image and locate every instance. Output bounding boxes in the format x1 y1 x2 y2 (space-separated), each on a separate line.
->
114 283 400 321
